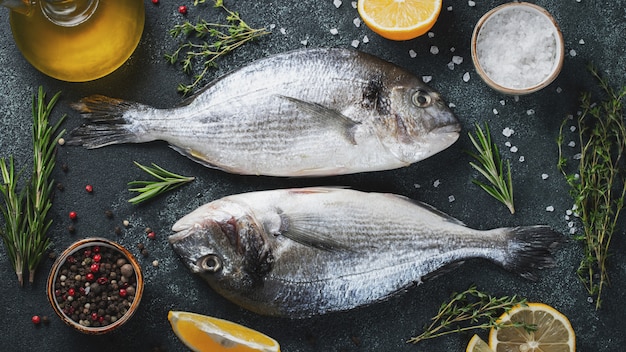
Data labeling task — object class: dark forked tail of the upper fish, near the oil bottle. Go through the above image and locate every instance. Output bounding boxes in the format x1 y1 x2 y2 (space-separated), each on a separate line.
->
67 95 152 149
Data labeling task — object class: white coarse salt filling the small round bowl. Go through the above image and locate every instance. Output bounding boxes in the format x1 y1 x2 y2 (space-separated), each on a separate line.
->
476 6 558 88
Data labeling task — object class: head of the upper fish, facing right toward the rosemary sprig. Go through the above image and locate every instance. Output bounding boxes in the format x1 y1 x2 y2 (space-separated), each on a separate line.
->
370 74 461 164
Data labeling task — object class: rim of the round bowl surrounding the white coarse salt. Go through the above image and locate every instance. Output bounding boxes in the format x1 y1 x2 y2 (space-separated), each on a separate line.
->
471 2 565 95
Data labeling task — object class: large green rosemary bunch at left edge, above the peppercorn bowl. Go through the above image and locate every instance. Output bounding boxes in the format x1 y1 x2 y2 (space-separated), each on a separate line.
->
0 87 65 286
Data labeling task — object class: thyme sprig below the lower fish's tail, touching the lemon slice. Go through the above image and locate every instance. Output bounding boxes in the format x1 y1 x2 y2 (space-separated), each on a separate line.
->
408 286 537 343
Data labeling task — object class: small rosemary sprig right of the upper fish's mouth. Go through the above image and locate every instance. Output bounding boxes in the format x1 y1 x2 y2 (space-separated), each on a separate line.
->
469 123 515 214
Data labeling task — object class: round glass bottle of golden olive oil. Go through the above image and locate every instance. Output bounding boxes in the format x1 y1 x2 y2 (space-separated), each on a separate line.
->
10 0 145 82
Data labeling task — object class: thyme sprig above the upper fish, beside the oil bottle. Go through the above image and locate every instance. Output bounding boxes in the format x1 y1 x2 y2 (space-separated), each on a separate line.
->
165 0 269 95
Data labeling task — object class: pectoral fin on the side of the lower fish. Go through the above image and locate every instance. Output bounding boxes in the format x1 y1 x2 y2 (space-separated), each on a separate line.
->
279 213 350 252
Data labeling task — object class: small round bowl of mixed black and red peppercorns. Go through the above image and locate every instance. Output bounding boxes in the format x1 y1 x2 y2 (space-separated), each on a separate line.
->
48 238 144 334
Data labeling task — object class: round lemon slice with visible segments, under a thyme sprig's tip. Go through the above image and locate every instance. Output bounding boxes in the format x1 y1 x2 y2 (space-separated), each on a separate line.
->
489 303 576 352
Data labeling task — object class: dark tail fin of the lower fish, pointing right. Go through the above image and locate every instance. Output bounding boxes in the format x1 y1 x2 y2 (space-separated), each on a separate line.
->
501 226 563 281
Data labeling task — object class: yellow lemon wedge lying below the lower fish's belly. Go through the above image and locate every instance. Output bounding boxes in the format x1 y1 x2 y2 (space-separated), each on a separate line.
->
167 311 280 352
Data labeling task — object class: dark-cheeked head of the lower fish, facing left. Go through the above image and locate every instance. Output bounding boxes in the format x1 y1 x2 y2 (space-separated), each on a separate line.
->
169 200 272 297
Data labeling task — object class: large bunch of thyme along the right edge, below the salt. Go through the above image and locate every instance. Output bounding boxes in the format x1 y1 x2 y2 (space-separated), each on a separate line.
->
557 66 626 309
